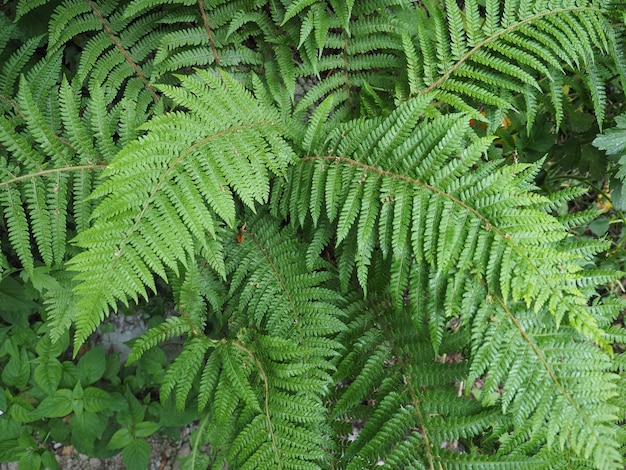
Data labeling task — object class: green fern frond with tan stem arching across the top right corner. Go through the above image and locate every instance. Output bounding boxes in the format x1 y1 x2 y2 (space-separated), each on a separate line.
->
414 2 612 122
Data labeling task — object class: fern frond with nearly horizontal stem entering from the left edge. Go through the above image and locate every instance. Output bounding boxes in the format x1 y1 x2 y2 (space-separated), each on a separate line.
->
0 66 130 278
